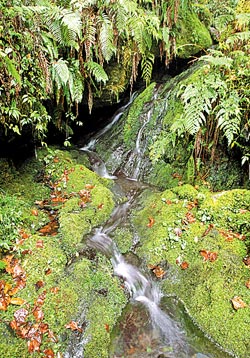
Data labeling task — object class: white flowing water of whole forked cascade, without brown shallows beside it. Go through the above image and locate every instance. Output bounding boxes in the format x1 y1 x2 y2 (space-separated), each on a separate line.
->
65 95 232 358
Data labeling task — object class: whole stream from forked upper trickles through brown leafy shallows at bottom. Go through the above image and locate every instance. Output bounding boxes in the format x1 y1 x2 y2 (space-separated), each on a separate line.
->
65 96 232 358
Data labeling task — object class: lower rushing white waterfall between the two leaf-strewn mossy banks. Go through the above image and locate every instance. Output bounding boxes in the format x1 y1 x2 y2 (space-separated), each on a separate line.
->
88 225 188 357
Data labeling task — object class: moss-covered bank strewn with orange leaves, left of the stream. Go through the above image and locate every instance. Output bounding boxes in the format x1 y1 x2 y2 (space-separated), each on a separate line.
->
0 148 127 358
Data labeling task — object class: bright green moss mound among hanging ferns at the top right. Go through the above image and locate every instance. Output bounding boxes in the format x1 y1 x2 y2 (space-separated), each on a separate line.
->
175 11 212 58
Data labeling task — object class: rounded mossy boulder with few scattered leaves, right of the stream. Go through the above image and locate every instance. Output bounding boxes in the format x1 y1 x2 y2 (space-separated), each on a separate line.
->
134 185 250 358
